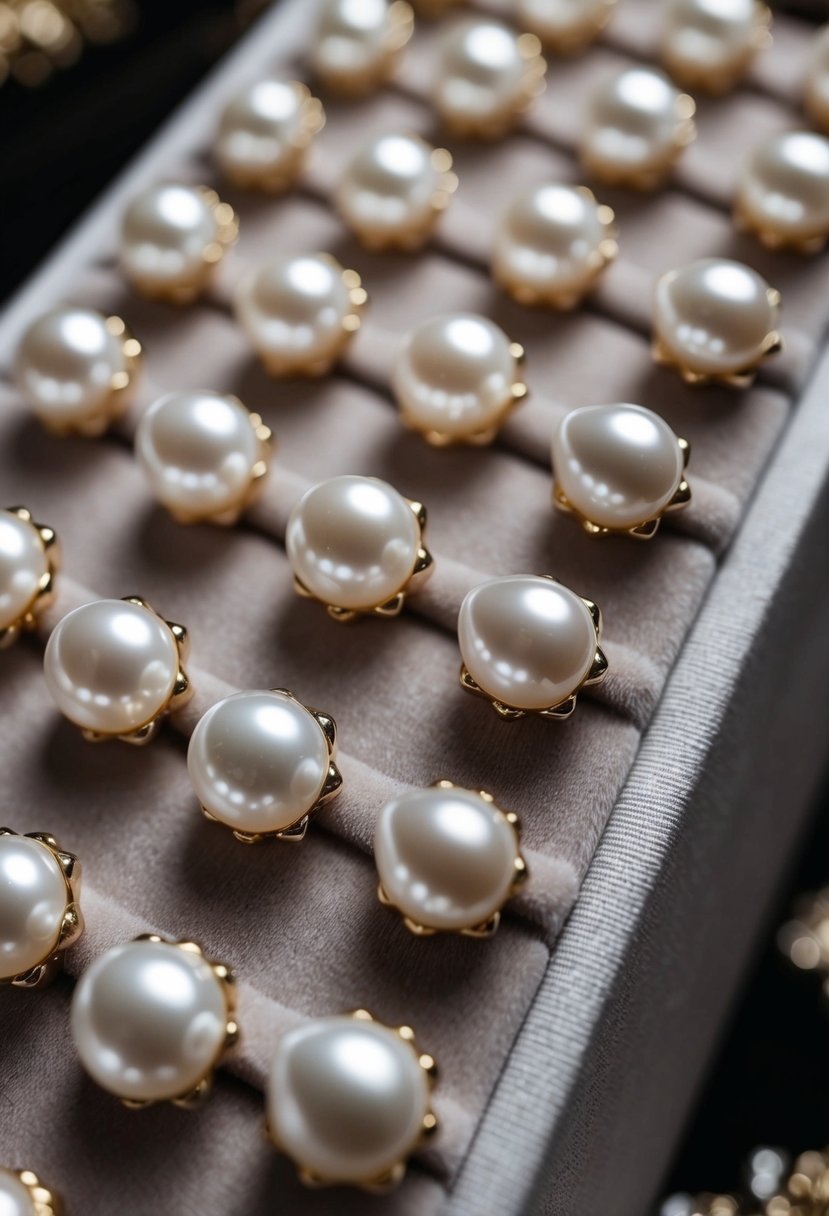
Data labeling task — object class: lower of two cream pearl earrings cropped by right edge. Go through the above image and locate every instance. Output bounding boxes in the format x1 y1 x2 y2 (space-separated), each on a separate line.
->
734 131 829 250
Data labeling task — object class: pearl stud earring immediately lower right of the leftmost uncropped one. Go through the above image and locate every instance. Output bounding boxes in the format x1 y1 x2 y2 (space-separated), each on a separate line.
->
135 392 271 524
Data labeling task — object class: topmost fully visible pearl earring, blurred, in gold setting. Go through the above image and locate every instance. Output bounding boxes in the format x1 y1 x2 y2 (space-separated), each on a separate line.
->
432 18 546 136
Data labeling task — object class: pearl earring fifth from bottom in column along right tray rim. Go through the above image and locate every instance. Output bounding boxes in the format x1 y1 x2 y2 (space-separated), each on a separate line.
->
653 258 783 388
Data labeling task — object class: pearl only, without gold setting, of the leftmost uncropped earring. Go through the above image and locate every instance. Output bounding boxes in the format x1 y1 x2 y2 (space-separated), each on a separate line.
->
16 308 126 428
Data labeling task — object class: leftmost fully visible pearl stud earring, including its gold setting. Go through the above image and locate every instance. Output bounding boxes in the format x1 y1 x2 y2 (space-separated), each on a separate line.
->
15 306 141 435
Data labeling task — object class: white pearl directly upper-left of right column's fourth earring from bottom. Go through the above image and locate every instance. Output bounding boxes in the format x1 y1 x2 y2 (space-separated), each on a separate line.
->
391 313 524 440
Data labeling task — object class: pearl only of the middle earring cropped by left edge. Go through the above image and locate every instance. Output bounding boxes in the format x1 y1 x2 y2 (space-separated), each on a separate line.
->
0 835 72 977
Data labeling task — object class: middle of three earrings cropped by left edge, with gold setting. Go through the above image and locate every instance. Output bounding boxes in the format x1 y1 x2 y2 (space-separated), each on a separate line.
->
0 828 84 987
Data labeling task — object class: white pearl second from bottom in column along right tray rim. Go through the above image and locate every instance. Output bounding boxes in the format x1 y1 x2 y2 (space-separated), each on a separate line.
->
374 787 519 933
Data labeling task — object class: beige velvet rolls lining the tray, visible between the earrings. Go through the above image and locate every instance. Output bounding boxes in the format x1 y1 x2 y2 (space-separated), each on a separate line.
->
0 0 829 1216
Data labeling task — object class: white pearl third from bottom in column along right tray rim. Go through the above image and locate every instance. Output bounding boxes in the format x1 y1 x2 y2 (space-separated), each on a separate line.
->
458 574 597 710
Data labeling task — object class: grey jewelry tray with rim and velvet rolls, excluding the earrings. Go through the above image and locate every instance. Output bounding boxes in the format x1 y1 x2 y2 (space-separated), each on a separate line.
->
0 0 829 1216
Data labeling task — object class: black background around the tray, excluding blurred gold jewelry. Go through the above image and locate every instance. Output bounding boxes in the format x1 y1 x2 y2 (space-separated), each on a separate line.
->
0 7 829 1216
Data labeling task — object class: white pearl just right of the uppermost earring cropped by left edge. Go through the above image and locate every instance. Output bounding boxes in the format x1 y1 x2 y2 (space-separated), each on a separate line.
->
44 599 179 734
